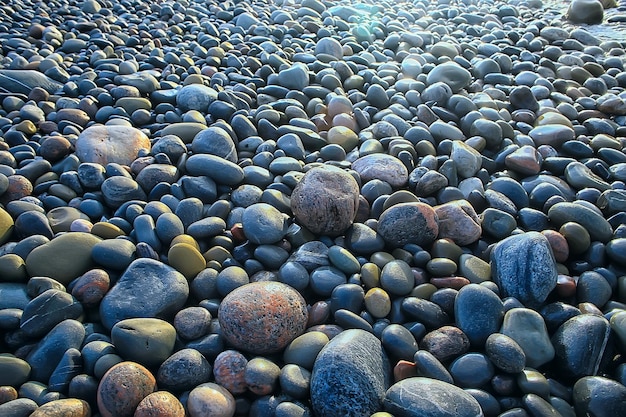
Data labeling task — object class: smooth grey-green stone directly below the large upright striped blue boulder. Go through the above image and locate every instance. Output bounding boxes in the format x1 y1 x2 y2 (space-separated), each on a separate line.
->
500 308 555 368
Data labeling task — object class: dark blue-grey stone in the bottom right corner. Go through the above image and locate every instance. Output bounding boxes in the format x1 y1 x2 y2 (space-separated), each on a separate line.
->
572 376 626 416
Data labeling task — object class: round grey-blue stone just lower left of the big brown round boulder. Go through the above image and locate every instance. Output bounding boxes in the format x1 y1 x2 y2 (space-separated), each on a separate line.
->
241 203 287 245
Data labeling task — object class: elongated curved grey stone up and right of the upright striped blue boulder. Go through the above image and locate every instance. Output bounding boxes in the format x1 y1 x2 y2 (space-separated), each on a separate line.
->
548 202 613 243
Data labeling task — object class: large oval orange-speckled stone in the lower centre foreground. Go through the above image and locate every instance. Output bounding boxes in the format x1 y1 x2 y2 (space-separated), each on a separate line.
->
218 281 308 354
